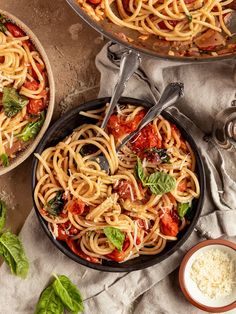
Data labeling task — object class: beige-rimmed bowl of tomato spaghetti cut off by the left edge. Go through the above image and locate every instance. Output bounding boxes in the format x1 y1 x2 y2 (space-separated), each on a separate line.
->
0 10 55 175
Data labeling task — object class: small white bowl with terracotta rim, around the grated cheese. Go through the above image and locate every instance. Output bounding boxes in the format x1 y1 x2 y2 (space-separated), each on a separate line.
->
179 240 236 313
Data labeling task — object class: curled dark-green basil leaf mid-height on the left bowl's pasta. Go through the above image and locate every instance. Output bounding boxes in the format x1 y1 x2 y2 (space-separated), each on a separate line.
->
2 87 29 118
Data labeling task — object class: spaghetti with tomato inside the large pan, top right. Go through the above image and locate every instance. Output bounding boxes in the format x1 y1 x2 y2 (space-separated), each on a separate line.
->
77 0 235 55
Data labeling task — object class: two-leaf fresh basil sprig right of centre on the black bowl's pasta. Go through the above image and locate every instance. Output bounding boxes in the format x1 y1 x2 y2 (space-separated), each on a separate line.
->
135 158 176 195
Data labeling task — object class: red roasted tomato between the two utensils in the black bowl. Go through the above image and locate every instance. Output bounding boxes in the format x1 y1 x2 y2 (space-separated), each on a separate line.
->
107 110 145 139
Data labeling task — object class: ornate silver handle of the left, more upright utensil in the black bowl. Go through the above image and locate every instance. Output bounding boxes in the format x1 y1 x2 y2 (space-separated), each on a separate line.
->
101 50 141 129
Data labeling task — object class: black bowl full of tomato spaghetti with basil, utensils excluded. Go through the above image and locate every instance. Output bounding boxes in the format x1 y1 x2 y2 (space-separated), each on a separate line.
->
32 98 205 272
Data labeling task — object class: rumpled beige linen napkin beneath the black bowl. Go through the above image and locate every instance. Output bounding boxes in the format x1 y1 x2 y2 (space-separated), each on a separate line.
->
0 46 236 314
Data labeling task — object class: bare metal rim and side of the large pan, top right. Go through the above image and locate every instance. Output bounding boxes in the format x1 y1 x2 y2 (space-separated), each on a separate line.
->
66 0 236 62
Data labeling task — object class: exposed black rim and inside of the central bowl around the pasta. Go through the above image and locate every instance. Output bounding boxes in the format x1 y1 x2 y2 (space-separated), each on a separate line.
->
32 97 205 272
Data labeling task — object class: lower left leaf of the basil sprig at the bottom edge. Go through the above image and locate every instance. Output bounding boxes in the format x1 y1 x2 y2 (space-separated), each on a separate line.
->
34 285 64 314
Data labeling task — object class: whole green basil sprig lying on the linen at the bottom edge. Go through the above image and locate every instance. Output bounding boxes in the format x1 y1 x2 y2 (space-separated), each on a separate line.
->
34 275 84 314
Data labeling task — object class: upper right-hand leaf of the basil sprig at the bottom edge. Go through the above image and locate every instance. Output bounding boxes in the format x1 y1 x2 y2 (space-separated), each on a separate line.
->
52 275 84 313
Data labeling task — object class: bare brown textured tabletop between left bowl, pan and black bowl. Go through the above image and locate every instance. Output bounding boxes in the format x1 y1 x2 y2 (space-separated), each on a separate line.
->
0 0 104 232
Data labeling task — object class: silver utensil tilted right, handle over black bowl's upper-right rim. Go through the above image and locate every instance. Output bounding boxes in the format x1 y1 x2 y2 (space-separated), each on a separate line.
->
95 83 184 173
